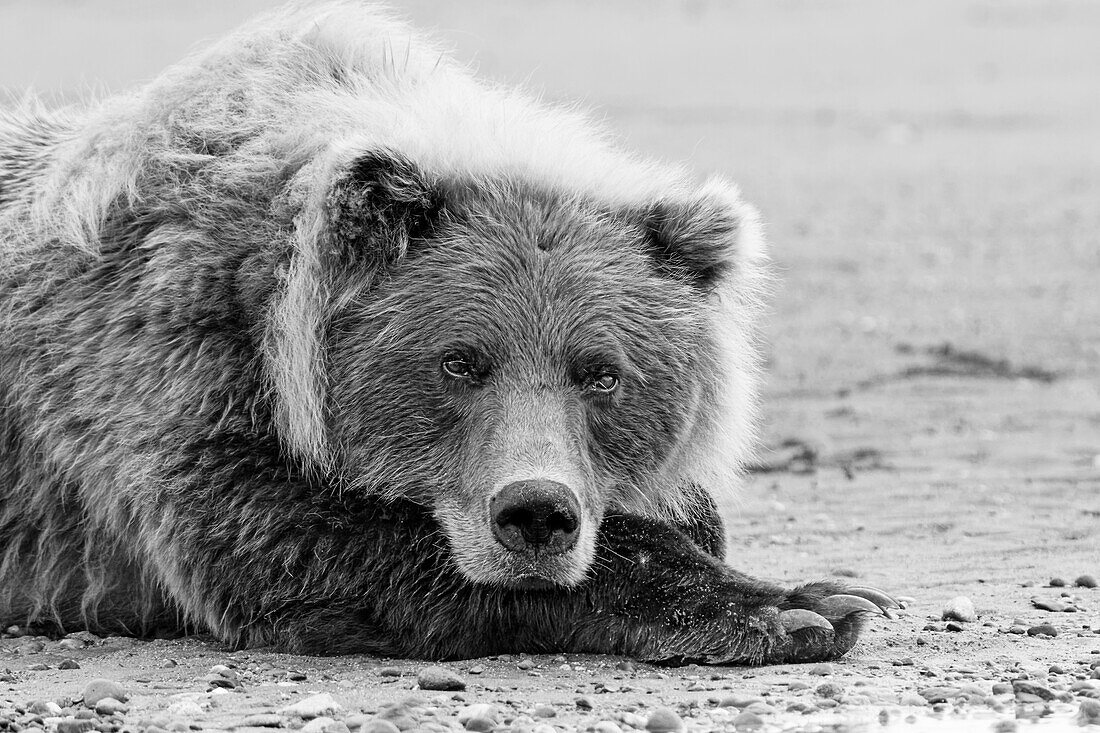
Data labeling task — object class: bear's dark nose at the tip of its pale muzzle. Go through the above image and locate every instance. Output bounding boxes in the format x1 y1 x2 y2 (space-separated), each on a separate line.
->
488 480 581 555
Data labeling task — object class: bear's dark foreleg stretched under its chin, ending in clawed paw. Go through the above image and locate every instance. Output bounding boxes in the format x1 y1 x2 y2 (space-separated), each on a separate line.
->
264 502 898 664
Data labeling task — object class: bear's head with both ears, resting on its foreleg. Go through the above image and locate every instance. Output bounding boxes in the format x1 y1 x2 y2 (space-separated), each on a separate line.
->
275 150 762 587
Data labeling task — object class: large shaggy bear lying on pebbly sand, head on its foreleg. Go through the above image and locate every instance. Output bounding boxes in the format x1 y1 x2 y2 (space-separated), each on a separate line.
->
0 2 897 664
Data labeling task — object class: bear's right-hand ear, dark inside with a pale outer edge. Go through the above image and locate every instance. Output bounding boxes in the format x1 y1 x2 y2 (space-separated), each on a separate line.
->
645 179 762 291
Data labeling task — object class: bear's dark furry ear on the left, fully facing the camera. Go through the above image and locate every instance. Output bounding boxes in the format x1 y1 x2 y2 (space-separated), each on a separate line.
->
327 151 442 270
